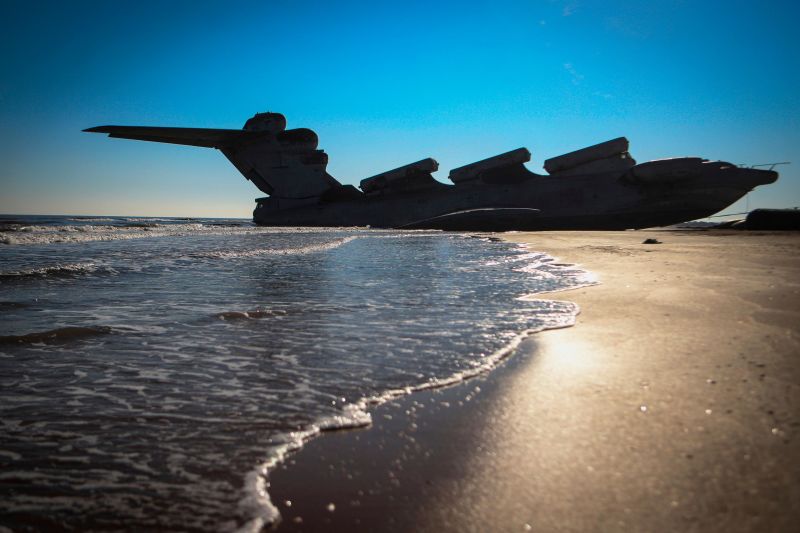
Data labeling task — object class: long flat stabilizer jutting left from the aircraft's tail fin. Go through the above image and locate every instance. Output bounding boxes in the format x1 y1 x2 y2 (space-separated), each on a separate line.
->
83 126 269 148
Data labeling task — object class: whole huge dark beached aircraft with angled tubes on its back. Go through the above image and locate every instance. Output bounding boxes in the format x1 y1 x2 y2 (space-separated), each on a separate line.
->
84 113 778 231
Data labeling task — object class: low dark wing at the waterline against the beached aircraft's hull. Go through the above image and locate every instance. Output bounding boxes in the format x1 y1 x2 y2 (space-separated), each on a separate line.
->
400 207 539 231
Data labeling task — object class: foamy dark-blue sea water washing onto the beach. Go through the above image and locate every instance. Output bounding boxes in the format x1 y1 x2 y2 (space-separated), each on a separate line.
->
0 215 592 531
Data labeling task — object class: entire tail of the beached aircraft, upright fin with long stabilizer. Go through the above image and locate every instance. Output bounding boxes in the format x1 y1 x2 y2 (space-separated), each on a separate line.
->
84 113 341 201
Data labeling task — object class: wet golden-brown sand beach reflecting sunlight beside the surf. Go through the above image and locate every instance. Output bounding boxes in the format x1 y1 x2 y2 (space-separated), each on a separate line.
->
269 231 800 531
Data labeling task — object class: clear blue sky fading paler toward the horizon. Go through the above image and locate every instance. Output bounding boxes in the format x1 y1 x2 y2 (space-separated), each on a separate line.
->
0 0 800 218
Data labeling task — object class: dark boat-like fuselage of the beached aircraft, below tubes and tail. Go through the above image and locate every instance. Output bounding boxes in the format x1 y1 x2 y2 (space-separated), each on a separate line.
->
253 162 777 231
